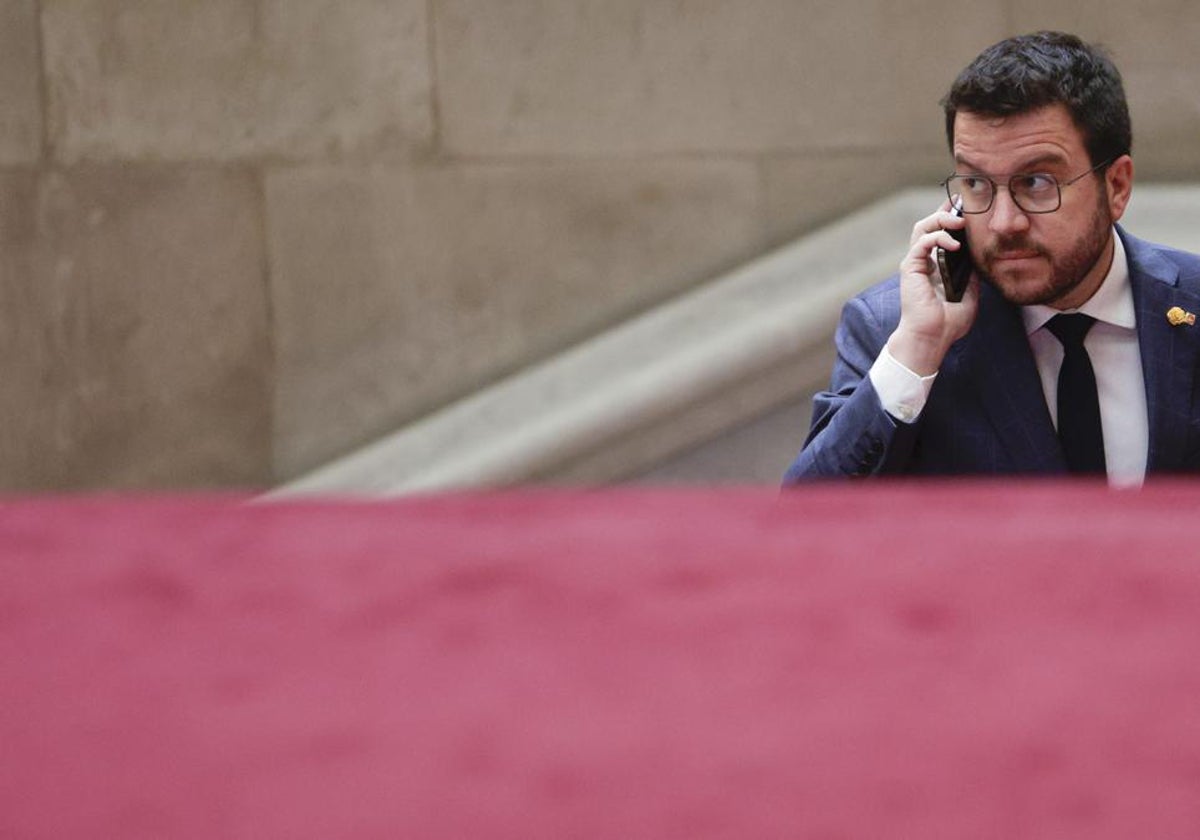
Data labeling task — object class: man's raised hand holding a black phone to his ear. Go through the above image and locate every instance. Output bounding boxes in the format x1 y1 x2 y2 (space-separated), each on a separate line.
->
888 200 979 376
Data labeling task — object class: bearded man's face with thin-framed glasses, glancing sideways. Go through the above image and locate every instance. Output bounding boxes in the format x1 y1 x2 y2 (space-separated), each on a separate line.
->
954 104 1132 310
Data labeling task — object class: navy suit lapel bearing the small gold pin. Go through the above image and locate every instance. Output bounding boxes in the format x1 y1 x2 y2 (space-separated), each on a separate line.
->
1121 232 1200 472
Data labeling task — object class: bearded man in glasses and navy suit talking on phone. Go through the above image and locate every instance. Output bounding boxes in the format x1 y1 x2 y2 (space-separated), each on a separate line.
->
785 32 1200 486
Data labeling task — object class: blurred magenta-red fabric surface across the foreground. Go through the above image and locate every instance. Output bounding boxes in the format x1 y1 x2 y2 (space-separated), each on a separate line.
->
0 482 1200 840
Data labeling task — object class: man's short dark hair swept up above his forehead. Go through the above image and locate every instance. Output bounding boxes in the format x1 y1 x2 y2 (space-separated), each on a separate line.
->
942 32 1133 166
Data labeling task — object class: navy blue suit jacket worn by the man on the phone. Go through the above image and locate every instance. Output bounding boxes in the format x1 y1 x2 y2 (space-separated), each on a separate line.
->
784 227 1200 482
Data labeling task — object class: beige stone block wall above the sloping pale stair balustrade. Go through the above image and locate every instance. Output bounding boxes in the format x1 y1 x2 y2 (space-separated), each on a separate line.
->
7 0 1200 491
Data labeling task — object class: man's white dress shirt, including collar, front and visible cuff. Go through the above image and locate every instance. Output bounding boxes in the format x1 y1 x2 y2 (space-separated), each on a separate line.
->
869 230 1150 487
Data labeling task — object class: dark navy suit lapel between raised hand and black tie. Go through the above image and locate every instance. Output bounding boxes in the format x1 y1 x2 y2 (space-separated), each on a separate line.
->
960 283 1066 473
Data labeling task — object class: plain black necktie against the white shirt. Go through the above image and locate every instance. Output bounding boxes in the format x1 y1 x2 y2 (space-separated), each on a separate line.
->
1046 313 1104 473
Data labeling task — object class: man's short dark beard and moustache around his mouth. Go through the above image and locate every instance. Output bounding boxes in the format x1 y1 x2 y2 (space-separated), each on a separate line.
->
977 187 1112 306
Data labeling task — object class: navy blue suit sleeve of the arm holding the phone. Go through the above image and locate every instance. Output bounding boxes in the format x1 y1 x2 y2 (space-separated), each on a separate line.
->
784 296 920 485
